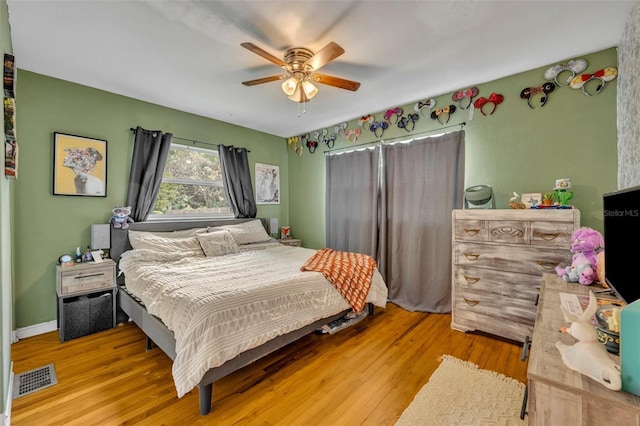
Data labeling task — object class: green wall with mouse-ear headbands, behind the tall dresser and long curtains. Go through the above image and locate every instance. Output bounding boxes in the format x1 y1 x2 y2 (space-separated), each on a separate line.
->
288 48 617 248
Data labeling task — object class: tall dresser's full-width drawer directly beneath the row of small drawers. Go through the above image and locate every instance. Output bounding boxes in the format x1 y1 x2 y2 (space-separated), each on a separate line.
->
453 243 571 276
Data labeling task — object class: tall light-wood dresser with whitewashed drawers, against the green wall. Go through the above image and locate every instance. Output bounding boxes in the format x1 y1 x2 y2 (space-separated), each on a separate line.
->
451 209 580 342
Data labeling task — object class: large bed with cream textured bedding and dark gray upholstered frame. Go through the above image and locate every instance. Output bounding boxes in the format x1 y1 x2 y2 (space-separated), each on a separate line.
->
111 219 387 415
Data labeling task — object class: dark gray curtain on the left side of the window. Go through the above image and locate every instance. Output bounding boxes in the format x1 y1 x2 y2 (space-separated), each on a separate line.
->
127 126 173 222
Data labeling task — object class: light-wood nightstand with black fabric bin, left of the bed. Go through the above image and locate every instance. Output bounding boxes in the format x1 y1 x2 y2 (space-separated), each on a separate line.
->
56 259 117 342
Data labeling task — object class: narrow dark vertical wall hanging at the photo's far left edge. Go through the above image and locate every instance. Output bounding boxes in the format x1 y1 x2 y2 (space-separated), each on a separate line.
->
3 53 18 178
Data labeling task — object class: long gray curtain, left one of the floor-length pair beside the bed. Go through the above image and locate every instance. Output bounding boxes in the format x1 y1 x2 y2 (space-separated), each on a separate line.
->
325 148 380 259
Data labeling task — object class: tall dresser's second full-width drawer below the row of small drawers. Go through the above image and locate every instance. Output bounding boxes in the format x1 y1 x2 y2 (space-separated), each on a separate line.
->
453 266 542 304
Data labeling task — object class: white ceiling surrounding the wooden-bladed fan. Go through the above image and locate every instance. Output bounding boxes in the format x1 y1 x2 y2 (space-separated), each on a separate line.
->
7 0 636 137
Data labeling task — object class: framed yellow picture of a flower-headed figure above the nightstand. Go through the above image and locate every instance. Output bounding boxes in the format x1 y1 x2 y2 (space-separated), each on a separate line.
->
53 132 107 197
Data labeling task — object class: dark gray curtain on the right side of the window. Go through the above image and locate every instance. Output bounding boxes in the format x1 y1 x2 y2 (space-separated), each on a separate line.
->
218 145 258 218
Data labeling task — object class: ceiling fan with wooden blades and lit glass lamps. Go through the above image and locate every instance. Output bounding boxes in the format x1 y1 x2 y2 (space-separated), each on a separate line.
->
241 42 360 102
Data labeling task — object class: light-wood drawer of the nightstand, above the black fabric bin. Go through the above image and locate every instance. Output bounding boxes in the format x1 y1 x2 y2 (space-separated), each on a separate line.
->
58 263 115 295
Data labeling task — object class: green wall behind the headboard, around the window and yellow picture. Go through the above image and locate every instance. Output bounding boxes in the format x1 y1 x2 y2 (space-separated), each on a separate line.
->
13 71 289 328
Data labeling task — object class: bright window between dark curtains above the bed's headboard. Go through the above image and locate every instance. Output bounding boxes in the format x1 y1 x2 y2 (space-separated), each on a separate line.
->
149 144 233 219
